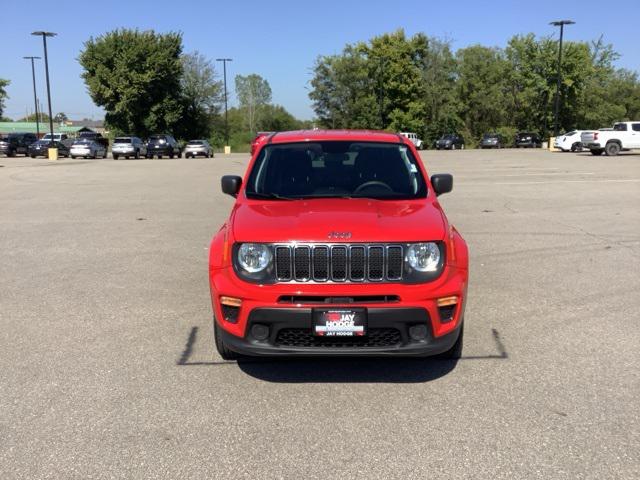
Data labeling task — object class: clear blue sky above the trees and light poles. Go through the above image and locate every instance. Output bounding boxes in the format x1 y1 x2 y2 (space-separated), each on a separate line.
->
0 0 640 119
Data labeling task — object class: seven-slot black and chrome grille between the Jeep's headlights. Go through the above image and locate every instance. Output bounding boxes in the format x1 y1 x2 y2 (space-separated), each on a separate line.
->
275 244 404 282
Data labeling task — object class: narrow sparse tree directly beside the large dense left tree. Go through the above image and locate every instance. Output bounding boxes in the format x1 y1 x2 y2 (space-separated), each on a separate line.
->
178 51 222 138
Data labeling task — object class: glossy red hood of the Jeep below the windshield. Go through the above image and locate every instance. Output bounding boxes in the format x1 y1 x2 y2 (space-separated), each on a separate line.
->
231 198 446 243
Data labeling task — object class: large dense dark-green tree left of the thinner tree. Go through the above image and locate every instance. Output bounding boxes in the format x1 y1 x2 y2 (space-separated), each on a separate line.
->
79 29 183 136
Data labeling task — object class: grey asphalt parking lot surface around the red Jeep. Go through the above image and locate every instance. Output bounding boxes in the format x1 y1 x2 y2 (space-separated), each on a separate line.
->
0 150 640 479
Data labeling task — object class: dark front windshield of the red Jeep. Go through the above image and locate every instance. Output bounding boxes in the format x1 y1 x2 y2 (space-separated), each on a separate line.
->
246 141 426 200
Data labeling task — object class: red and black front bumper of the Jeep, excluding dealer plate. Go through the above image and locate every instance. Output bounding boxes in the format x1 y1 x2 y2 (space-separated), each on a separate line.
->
210 265 468 356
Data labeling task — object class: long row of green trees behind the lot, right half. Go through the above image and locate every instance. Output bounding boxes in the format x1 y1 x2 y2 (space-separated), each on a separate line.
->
309 30 640 146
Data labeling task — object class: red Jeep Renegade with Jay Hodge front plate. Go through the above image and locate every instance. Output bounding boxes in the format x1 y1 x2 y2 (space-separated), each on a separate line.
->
209 130 468 359
